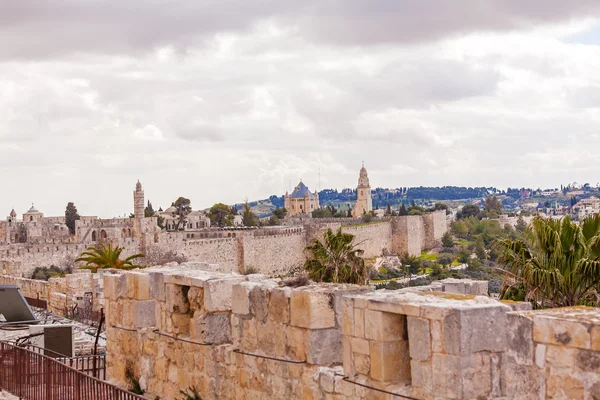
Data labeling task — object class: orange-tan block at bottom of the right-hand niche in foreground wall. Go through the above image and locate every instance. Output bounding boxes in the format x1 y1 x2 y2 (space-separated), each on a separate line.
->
370 341 410 382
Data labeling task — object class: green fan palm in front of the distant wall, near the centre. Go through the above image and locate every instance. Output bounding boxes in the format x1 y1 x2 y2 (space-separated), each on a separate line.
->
304 228 369 285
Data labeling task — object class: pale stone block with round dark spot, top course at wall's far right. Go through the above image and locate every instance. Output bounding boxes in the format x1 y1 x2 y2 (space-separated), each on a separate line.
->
533 314 592 349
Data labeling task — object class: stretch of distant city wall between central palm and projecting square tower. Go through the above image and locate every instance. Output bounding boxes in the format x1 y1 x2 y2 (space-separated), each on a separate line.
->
342 222 392 258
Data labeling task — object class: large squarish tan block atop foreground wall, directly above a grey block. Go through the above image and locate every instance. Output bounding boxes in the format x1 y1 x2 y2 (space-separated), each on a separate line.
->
290 289 335 329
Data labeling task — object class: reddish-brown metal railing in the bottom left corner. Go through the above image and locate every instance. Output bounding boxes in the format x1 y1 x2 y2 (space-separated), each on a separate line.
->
0 342 145 400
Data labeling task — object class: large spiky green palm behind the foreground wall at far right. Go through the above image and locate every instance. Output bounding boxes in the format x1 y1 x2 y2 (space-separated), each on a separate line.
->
497 215 600 308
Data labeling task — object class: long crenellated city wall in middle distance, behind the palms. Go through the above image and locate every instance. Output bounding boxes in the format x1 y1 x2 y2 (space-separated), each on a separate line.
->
0 211 447 278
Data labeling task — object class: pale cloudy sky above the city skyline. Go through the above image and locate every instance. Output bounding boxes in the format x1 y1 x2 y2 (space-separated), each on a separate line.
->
0 0 600 217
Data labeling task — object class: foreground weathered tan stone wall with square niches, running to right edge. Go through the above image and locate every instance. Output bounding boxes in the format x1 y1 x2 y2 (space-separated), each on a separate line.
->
104 269 600 400
